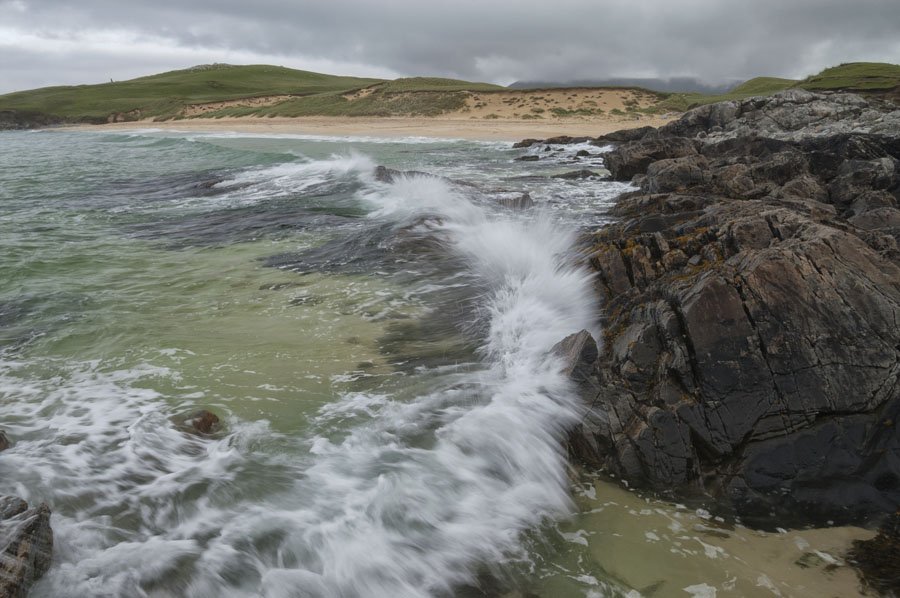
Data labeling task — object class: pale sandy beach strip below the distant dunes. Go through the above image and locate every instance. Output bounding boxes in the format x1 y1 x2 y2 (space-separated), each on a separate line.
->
56 115 679 141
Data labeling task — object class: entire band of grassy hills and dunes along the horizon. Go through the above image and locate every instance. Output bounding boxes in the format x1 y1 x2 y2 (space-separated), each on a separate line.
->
0 63 900 129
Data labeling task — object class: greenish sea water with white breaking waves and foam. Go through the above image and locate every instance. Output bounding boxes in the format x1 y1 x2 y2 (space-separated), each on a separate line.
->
0 130 868 598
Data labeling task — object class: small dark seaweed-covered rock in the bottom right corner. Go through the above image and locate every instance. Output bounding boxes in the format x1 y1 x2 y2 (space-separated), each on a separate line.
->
847 511 900 596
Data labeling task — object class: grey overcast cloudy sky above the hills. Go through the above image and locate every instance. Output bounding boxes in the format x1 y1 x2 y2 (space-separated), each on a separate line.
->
0 0 900 93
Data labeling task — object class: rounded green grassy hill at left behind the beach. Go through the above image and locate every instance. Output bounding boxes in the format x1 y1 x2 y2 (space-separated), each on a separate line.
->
0 64 502 123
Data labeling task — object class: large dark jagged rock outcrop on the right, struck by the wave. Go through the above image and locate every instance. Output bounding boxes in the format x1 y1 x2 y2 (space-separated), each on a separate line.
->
572 92 900 520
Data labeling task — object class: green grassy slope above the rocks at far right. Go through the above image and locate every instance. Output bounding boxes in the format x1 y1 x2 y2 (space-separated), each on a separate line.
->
660 62 900 111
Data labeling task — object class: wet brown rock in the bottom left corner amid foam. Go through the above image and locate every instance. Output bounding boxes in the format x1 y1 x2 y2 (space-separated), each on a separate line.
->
0 496 53 598
